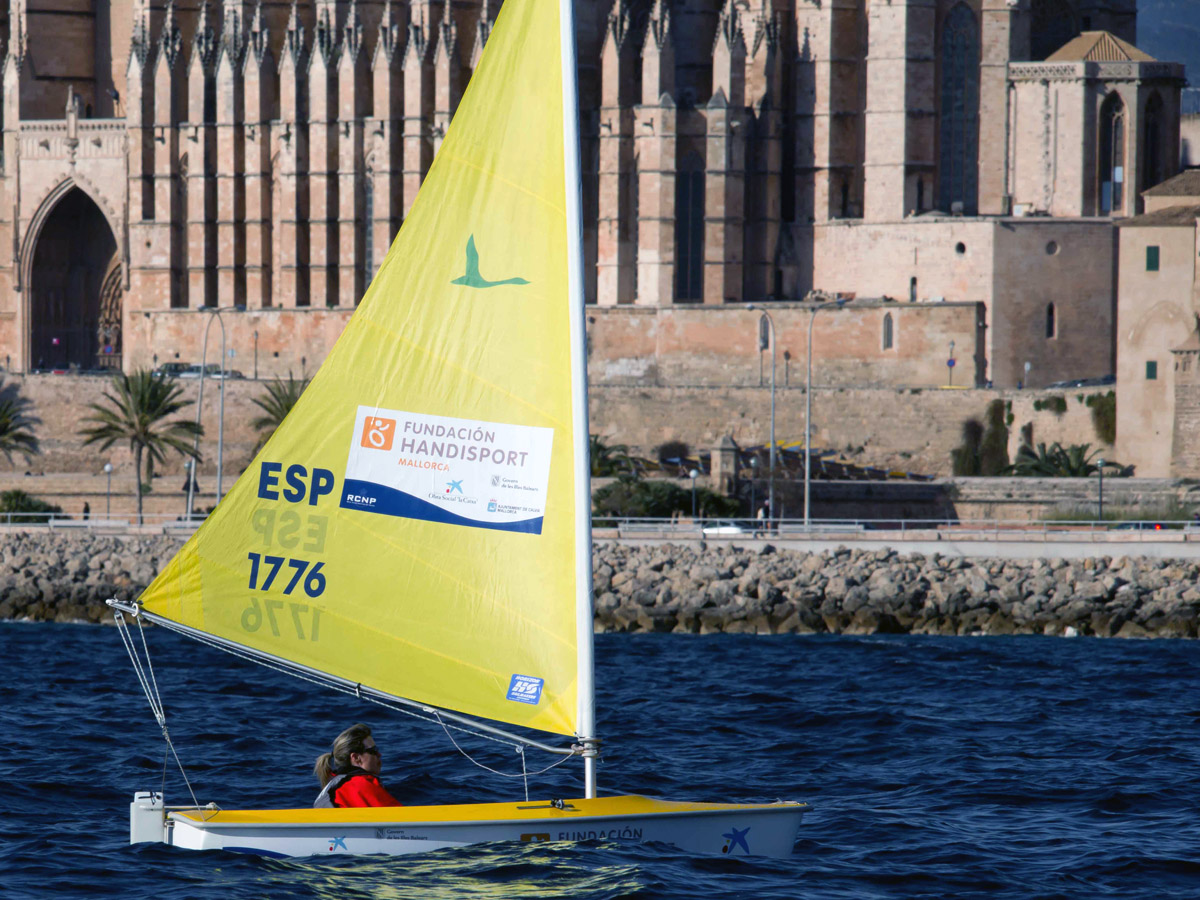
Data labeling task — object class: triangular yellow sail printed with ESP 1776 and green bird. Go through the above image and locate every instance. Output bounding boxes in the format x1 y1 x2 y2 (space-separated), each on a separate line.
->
140 0 586 734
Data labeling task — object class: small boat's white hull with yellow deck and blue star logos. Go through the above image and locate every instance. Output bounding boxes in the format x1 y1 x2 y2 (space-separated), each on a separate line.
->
143 796 808 857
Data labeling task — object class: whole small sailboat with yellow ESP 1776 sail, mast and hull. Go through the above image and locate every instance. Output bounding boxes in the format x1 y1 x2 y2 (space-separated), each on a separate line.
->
109 0 806 857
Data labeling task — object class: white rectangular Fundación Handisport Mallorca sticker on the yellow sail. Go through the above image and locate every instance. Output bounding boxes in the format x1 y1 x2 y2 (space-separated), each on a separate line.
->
340 406 554 535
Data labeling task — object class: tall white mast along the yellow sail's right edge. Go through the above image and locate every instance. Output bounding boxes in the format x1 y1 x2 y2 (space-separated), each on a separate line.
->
558 0 596 797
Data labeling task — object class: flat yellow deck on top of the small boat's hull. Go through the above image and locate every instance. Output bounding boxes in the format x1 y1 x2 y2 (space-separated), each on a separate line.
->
172 794 806 826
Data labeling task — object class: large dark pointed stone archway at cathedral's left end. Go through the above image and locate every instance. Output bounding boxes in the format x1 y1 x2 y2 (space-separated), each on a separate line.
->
29 187 122 370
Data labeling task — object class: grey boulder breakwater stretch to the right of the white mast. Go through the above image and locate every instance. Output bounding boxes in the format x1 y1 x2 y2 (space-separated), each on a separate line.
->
593 542 1200 637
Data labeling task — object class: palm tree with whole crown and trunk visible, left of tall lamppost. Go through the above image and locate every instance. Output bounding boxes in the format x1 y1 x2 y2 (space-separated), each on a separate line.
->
79 368 204 524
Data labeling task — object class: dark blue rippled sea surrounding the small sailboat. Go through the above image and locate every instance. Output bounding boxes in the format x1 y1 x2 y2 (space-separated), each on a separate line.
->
0 624 1200 900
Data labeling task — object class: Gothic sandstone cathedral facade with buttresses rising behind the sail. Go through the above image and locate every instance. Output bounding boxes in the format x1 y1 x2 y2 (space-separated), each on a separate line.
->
0 0 1182 386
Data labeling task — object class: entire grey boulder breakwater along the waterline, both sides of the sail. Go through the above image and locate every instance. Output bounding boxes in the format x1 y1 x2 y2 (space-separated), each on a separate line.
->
7 532 1200 637
